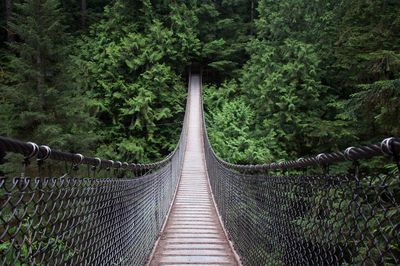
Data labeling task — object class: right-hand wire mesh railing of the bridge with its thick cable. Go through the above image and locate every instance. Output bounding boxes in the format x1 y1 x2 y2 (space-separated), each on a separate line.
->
203 80 400 265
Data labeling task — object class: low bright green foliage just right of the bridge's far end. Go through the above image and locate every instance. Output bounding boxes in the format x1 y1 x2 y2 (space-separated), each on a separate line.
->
205 82 282 164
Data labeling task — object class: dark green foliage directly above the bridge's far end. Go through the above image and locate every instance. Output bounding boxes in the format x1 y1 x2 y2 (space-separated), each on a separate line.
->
196 0 254 82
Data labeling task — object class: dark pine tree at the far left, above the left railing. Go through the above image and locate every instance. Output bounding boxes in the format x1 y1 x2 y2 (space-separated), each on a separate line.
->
0 0 93 151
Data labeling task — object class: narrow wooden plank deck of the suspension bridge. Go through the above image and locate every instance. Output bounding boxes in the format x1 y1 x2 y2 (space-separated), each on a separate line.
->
150 76 238 265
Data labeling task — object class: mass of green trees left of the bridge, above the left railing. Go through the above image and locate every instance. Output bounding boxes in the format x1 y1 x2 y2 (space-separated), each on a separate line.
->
0 0 201 164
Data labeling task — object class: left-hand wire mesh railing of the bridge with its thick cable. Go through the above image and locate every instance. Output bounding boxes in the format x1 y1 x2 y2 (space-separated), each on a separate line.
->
0 87 190 265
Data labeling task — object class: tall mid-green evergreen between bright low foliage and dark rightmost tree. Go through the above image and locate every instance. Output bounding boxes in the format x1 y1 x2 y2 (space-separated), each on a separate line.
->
230 0 350 159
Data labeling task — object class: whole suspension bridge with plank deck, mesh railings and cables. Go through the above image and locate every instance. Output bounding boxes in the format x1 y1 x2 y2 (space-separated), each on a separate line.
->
0 74 400 265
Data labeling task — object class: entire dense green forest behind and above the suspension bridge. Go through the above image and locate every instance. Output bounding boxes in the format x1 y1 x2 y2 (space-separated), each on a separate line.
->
0 0 400 163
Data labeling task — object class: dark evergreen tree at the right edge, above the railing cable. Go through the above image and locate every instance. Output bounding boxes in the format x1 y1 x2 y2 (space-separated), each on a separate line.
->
334 0 400 141
